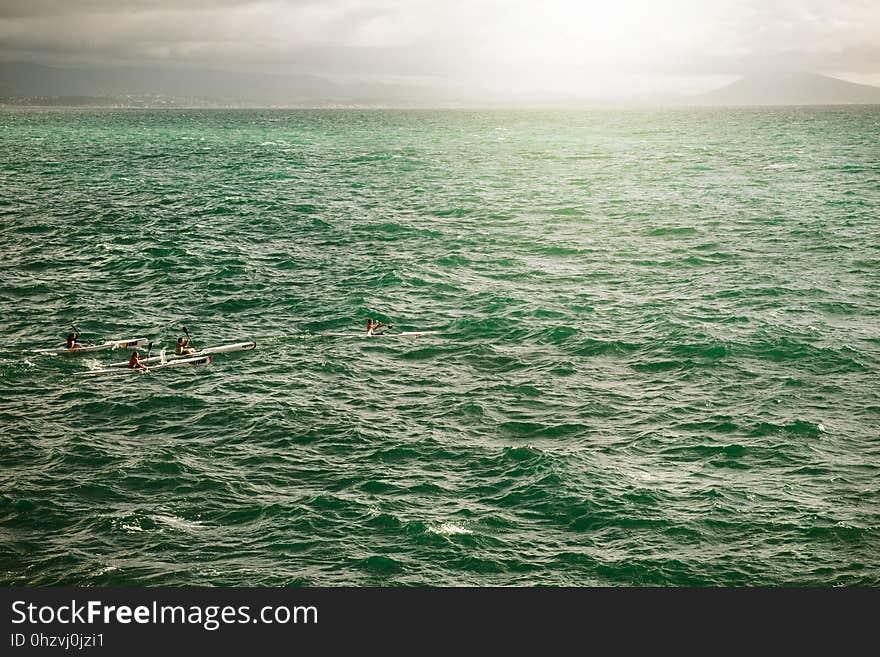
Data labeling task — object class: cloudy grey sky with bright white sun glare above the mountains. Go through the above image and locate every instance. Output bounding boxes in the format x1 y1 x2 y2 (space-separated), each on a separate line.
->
0 0 880 97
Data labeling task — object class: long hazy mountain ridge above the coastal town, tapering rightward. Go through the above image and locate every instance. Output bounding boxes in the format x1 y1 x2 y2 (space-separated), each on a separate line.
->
0 62 434 106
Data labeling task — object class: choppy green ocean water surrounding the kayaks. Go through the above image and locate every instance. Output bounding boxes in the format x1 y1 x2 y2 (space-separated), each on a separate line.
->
0 107 880 587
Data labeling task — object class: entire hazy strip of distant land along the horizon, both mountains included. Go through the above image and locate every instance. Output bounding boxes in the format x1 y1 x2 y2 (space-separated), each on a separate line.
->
0 62 880 110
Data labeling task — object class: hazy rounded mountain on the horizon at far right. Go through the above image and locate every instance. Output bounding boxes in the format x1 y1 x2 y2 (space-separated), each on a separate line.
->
691 72 880 105
